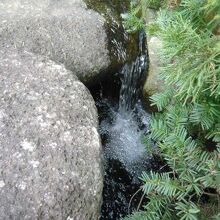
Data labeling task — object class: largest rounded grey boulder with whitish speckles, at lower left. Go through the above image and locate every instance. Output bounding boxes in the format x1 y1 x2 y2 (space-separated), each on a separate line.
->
0 48 103 220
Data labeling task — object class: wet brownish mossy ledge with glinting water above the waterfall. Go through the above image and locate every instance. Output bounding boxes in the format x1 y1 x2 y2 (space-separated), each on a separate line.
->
84 0 131 63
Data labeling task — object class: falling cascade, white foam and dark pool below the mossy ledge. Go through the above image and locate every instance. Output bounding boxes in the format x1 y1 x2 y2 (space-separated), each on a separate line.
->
90 32 162 220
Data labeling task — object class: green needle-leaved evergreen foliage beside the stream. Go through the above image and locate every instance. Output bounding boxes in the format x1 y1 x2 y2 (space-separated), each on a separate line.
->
125 0 220 220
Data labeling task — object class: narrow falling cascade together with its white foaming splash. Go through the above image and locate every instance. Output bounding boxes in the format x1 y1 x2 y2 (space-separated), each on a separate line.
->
100 29 149 181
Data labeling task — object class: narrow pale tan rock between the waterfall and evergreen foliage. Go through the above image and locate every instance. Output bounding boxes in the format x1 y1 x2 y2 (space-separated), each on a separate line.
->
143 37 164 96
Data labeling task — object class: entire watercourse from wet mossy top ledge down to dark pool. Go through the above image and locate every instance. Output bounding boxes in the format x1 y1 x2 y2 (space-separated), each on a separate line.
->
87 0 160 220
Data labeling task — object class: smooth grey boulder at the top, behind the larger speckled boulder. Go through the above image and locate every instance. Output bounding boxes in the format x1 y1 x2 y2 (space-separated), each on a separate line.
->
0 0 110 83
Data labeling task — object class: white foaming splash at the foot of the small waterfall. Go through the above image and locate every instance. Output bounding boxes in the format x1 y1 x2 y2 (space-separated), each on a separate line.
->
100 105 150 177
